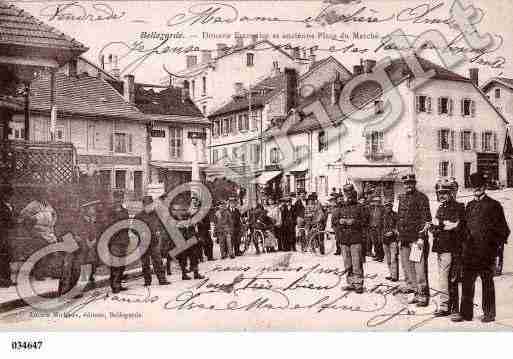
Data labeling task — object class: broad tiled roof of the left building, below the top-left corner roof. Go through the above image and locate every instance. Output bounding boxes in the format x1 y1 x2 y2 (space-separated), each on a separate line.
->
30 73 146 121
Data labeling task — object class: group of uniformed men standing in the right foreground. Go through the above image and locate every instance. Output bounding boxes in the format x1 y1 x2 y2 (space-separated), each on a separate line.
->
331 173 510 322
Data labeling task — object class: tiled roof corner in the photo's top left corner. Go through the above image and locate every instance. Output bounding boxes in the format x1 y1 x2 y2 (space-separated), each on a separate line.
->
0 0 87 52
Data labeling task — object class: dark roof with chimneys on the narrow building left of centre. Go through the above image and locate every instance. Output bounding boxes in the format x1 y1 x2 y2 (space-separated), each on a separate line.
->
135 85 203 117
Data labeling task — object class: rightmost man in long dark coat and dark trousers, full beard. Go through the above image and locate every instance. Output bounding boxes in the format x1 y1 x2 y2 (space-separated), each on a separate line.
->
452 173 510 323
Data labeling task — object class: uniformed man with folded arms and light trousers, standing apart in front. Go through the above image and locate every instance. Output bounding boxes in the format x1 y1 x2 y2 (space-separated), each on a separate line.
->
331 184 368 294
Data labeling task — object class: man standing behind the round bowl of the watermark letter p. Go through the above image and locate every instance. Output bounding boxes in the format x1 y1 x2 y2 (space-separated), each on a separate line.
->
170 195 205 280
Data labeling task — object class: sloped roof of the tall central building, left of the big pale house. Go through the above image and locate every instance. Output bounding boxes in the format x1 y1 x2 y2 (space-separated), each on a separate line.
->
209 73 285 117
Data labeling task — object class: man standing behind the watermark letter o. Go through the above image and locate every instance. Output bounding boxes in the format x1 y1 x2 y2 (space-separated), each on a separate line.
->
103 190 129 294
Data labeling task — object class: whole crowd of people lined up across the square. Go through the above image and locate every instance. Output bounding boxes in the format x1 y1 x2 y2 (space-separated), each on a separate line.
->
0 173 510 322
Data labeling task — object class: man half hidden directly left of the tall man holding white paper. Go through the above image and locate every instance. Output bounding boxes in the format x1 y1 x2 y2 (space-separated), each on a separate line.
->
383 201 399 282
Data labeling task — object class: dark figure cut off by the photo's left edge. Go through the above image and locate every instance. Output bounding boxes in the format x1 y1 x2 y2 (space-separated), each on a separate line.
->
0 184 14 288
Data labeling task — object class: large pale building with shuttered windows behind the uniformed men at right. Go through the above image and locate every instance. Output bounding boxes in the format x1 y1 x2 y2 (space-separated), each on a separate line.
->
266 56 507 199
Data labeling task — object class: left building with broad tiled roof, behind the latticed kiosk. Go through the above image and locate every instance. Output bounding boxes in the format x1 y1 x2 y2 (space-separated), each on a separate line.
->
10 66 148 199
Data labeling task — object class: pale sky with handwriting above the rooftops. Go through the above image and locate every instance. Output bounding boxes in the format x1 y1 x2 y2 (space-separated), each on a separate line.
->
9 0 513 83
